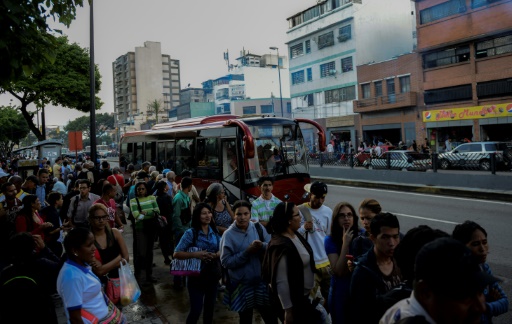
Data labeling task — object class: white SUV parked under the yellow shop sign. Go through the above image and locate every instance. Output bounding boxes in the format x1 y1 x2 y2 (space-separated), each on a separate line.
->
438 142 512 171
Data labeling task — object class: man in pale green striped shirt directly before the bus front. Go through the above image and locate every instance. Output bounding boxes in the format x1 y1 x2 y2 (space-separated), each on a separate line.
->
251 177 281 227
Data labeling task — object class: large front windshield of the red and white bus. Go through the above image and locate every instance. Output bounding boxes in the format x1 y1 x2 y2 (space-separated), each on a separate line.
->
246 124 308 182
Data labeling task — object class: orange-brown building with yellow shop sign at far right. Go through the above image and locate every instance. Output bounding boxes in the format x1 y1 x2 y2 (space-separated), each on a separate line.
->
415 0 512 150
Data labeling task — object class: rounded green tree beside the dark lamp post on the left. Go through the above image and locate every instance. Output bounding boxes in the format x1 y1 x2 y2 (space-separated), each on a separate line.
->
4 36 102 140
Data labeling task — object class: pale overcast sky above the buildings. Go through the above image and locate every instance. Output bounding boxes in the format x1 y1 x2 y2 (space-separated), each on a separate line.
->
0 0 316 125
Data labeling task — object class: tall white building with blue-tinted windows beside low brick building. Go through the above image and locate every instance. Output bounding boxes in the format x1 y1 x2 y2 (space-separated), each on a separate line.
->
287 0 416 145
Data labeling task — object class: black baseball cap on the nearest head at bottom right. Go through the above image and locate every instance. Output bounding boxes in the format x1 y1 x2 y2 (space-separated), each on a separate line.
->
414 237 499 299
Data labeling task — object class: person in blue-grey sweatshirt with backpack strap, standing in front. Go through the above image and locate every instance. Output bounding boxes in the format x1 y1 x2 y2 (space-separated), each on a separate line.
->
220 200 277 324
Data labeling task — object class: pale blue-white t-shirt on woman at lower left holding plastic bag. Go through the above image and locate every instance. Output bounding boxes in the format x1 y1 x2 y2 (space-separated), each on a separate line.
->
57 260 108 324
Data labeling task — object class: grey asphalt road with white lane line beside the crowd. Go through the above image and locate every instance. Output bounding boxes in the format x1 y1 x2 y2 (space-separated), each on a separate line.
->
325 185 512 323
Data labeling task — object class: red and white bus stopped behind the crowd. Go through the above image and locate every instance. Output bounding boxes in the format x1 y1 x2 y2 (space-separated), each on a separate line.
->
119 115 325 202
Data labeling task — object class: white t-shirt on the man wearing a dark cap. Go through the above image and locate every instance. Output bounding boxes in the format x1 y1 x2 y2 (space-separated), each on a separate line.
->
298 204 332 269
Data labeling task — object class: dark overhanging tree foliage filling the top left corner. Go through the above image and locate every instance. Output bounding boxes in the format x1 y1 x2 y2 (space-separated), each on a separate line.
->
0 0 85 86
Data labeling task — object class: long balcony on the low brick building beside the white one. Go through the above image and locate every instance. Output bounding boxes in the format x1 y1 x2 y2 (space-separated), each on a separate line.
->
354 92 417 113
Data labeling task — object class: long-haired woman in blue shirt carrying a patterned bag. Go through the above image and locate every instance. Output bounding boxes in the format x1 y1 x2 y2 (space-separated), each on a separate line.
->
173 203 222 324
